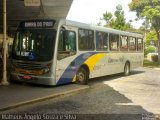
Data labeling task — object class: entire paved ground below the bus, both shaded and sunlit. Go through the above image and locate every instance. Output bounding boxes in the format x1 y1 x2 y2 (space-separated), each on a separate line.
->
0 68 160 120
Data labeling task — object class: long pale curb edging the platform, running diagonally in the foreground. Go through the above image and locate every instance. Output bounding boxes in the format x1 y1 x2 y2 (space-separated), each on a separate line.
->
0 86 90 112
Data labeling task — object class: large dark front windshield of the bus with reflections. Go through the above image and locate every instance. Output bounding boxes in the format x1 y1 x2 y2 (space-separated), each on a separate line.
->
12 28 56 61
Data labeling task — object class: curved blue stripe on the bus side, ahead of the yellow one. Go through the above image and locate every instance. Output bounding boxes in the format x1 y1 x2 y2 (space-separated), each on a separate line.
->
57 52 96 85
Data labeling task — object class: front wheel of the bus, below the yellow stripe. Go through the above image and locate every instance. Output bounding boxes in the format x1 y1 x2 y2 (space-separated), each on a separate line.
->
76 67 88 85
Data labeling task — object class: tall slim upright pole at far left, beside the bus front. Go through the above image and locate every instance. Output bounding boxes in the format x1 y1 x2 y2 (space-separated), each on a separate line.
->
1 0 9 85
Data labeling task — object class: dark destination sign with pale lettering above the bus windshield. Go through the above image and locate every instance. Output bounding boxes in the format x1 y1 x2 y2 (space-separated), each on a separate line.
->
21 20 55 28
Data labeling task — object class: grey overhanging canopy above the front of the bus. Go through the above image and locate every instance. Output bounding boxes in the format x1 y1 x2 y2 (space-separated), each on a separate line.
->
0 0 73 33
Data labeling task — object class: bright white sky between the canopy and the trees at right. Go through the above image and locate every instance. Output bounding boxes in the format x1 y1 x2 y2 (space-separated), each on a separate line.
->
67 0 142 28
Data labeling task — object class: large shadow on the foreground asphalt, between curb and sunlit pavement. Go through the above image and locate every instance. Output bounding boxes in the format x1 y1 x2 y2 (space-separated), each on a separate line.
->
3 84 152 120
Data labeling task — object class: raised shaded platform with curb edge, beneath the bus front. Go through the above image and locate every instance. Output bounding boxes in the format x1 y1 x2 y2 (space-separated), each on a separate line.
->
0 83 88 111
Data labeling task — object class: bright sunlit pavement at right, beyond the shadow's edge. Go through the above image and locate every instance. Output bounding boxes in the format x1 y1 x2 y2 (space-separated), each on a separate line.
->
104 68 160 114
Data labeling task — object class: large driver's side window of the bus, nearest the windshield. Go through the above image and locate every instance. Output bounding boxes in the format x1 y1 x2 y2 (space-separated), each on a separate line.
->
58 30 76 60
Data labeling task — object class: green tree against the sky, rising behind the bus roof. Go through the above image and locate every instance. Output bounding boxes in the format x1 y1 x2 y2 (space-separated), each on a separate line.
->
103 5 130 30
